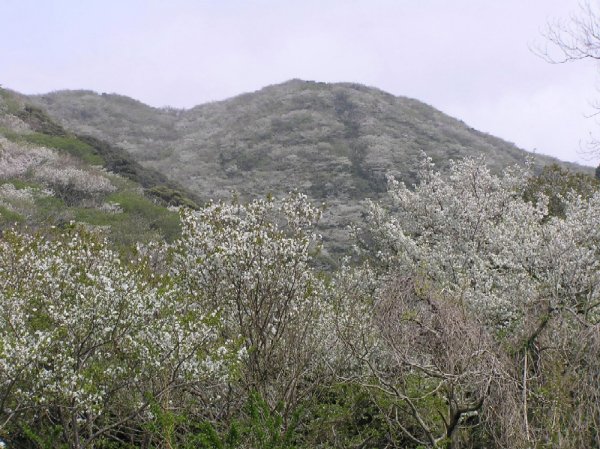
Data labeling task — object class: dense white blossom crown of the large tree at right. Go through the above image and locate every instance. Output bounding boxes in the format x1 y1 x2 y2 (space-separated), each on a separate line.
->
369 159 600 327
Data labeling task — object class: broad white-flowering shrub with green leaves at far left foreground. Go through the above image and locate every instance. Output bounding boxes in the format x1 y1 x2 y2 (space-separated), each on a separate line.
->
0 229 232 448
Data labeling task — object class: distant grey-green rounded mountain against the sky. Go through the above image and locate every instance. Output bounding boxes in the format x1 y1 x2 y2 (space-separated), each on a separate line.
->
30 80 582 260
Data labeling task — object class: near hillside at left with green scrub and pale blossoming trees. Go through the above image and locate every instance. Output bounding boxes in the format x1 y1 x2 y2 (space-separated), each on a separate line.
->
0 89 194 245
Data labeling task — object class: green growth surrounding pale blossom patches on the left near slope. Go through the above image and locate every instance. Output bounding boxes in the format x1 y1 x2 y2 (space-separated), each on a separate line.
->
0 91 192 247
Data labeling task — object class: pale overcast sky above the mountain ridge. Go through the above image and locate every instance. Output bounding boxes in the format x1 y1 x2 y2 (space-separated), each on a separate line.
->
0 0 600 165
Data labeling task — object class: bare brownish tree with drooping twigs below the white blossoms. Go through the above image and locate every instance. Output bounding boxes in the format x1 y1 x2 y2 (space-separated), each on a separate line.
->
348 276 524 448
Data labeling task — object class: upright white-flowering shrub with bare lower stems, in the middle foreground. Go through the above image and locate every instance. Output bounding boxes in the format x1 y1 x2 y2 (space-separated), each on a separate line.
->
171 194 326 414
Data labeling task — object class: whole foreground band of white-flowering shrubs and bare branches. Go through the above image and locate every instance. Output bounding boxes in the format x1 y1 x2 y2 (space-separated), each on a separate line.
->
0 153 600 449
